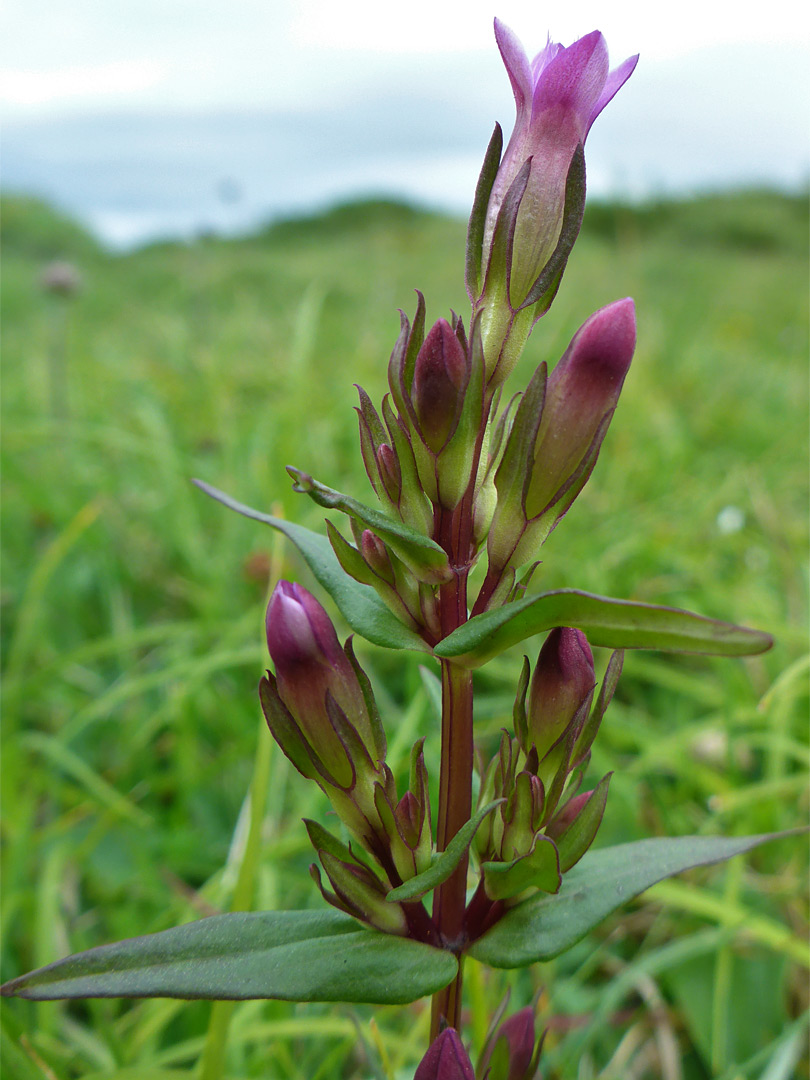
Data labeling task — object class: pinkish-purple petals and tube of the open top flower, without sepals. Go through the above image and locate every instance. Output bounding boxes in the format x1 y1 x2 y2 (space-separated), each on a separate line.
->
483 19 638 306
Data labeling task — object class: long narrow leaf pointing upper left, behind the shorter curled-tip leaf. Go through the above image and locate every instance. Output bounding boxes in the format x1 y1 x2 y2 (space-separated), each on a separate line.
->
193 480 430 652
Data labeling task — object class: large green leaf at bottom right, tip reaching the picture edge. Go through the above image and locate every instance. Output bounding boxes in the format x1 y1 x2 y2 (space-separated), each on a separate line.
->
470 829 804 968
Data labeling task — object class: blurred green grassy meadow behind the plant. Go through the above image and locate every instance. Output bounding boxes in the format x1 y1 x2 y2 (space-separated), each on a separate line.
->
1 192 808 1080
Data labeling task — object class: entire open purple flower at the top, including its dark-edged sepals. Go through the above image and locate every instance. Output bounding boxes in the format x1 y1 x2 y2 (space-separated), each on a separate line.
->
475 19 638 389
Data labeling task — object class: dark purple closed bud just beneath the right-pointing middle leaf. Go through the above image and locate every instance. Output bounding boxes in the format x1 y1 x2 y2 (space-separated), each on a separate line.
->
528 626 596 761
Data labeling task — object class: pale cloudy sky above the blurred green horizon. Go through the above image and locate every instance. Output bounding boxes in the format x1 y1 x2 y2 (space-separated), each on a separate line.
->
2 0 810 249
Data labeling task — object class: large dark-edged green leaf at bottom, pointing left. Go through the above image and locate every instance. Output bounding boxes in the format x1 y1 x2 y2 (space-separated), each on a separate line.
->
2 912 458 1004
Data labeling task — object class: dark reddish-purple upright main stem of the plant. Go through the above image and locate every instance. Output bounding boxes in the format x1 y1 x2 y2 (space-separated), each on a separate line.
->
430 499 473 1041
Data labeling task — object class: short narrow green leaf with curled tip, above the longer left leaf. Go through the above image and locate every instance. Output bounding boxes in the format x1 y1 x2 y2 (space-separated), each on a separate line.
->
287 465 453 584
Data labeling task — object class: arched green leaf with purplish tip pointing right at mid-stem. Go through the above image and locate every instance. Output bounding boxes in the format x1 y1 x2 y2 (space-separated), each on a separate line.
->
433 589 773 667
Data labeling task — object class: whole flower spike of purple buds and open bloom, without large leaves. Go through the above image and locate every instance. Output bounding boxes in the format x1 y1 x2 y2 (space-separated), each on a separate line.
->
260 23 635 948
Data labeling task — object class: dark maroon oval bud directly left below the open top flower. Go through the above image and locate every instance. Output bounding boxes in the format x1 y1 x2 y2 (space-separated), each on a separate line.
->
410 319 470 454
